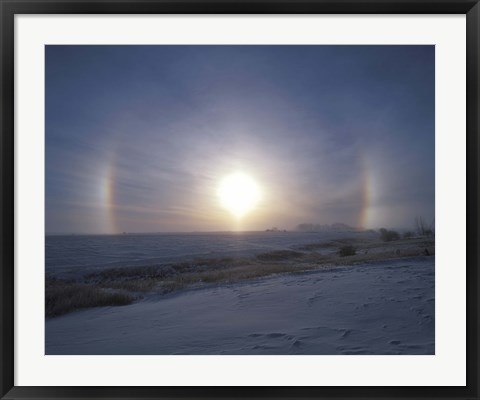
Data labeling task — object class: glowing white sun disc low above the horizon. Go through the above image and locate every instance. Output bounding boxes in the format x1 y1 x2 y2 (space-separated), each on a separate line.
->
217 172 260 218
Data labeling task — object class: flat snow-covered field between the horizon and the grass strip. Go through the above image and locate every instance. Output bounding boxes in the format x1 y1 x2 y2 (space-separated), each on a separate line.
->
45 228 378 278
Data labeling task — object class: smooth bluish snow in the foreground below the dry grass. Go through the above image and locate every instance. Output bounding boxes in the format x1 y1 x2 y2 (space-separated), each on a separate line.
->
45 257 435 355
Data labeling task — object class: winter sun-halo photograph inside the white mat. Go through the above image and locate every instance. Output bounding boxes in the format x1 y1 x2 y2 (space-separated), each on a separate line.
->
45 44 435 356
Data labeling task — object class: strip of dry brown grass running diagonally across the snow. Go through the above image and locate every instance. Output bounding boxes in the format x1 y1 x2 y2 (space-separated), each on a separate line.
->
46 238 435 317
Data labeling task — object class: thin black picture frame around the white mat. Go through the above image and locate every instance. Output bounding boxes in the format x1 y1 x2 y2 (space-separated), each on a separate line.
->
0 0 480 399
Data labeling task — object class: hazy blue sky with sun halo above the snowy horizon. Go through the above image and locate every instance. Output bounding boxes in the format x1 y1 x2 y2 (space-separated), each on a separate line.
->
45 45 435 233
